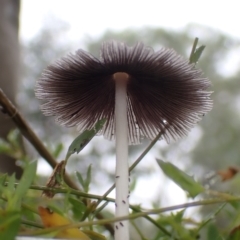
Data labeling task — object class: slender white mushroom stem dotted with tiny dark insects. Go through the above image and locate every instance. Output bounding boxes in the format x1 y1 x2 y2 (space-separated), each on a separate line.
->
113 72 129 240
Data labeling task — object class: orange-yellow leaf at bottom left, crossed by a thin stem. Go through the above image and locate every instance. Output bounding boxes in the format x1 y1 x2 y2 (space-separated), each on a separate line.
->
38 207 91 240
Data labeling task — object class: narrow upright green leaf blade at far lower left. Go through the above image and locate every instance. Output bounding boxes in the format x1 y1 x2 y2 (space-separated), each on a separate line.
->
8 161 37 210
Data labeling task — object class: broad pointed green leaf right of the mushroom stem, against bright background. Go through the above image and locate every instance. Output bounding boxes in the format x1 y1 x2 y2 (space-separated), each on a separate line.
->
157 159 204 198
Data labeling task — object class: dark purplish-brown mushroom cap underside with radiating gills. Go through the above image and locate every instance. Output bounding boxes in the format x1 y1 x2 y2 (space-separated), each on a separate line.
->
35 41 212 144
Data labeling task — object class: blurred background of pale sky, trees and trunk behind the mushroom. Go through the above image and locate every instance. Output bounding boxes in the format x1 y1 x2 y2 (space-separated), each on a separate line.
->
0 0 240 238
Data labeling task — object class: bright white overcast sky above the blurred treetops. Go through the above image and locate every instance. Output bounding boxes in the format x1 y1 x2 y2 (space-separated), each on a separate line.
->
20 0 240 40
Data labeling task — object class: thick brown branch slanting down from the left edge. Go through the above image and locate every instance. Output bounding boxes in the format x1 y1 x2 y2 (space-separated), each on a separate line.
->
0 88 114 235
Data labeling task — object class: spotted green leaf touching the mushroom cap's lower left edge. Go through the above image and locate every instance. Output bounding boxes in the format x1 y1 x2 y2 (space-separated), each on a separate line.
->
65 119 106 161
